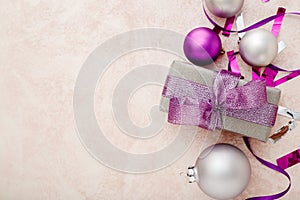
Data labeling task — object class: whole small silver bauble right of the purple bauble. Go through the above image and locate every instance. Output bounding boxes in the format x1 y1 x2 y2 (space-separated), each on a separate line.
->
239 29 278 67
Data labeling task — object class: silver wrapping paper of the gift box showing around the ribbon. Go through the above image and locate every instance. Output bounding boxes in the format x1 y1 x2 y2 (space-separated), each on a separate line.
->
160 61 281 142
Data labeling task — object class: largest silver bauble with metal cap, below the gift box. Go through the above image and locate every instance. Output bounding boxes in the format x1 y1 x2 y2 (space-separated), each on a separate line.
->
187 144 251 200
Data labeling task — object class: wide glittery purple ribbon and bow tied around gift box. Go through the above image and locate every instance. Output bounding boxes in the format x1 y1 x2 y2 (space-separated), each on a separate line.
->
162 70 278 130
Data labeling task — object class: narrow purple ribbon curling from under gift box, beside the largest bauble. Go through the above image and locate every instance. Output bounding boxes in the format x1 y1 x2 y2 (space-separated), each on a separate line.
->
244 137 291 200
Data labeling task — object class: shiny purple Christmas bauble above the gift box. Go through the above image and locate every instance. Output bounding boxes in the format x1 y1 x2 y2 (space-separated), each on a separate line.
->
183 27 222 66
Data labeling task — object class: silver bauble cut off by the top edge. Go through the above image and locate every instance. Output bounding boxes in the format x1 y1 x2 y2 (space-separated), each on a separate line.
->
205 0 244 18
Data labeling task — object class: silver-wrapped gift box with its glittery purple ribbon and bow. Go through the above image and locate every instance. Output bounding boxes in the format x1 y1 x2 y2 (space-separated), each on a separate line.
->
160 61 281 141
